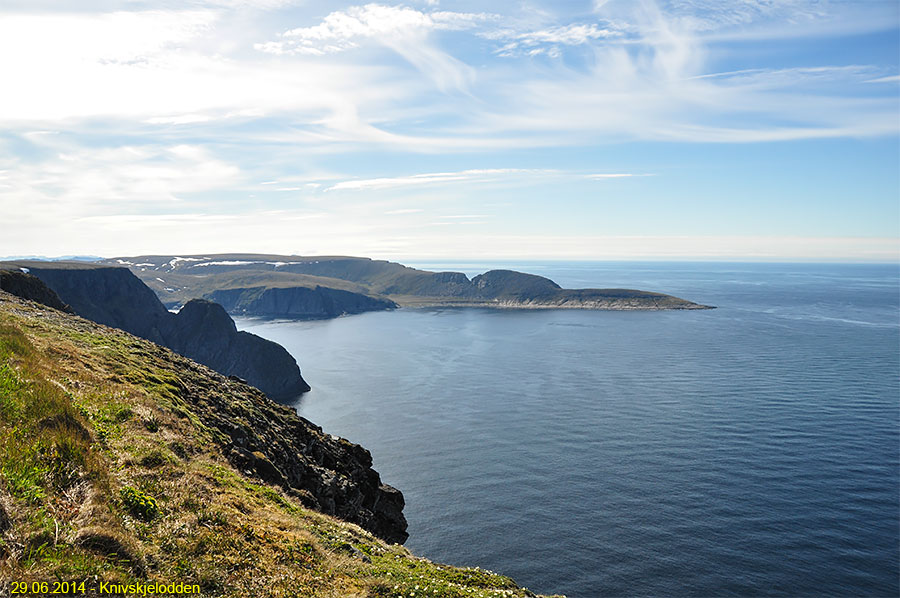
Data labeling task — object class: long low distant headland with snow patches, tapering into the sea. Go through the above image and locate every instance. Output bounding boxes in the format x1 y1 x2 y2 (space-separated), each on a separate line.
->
100 254 711 319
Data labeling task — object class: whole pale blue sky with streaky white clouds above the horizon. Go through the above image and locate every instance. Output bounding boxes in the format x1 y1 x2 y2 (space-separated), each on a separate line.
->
0 0 900 262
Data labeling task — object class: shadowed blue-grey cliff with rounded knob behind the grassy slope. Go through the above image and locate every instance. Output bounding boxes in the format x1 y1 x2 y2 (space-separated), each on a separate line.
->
1 263 309 399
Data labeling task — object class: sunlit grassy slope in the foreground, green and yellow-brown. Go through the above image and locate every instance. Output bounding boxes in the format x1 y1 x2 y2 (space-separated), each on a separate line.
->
0 293 560 597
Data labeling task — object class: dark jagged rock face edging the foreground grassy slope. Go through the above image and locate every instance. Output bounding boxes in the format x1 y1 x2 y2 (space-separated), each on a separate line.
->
164 362 409 544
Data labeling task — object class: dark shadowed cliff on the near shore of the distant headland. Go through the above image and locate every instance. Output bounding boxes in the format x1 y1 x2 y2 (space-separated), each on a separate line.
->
207 286 397 319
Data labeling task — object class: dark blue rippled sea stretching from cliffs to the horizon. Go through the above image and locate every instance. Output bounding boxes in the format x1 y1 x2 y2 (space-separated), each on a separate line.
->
239 263 900 598
